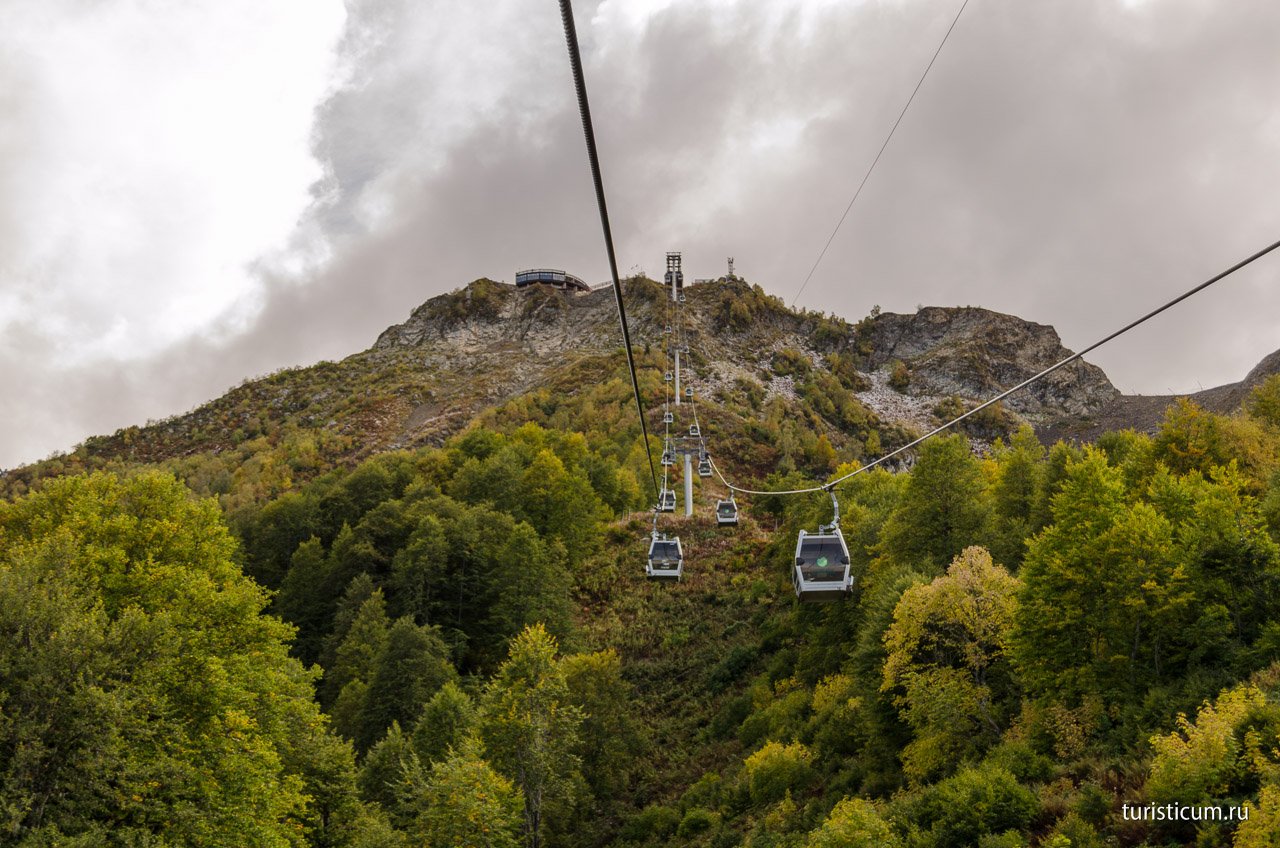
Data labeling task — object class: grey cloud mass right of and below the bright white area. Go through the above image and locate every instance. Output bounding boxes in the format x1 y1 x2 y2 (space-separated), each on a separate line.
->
0 0 1280 461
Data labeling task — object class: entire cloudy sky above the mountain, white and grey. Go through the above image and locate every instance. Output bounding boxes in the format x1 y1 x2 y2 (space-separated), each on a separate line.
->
0 0 1280 468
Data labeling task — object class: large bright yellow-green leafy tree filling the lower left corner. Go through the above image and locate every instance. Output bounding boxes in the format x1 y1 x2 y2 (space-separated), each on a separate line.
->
0 473 373 847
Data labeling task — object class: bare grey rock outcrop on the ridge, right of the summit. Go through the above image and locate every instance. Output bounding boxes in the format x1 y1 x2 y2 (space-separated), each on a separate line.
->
869 306 1119 420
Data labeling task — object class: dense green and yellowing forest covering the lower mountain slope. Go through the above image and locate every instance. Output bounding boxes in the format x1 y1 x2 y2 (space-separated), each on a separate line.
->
0 327 1280 848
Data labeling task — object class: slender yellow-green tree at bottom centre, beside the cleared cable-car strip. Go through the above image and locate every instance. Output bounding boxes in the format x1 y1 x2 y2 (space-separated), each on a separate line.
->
480 624 582 848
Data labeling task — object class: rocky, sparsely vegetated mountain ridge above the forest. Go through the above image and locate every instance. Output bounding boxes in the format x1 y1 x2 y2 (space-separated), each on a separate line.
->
8 278 1280 491
